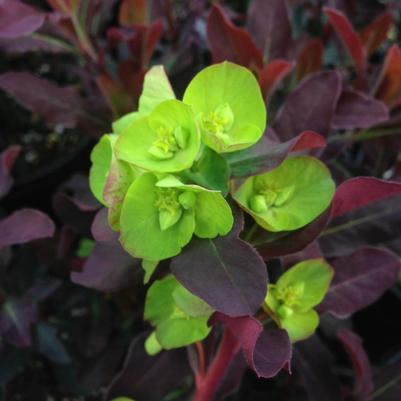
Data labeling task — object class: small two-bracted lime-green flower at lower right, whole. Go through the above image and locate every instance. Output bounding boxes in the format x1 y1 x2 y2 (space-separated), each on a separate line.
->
264 259 334 342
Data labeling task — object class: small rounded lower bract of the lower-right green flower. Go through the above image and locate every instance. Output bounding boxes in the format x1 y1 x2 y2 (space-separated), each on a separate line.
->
280 309 319 343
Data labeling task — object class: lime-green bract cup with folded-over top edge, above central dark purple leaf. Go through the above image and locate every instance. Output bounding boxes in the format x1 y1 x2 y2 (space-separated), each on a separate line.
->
120 173 233 261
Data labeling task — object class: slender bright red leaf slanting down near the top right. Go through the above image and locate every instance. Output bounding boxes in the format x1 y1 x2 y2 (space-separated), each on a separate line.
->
323 7 367 78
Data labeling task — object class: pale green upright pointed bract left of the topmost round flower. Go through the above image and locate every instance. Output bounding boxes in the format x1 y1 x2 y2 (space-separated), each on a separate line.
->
139 65 175 114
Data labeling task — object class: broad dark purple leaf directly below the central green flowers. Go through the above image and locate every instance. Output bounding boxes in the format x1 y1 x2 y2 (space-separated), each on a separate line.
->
171 227 267 317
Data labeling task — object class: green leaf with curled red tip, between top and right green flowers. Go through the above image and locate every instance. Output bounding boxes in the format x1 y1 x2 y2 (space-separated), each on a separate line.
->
226 131 326 177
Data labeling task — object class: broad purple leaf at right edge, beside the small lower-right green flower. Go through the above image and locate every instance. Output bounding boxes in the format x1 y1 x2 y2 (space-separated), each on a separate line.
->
317 247 401 319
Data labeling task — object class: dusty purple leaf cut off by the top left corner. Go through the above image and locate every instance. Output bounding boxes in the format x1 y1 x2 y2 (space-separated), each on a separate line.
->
0 0 45 38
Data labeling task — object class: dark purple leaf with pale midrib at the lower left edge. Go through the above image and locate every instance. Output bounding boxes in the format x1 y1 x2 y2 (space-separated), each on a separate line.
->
0 297 38 347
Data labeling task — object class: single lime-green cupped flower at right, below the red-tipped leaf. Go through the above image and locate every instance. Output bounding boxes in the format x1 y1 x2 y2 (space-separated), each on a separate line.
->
233 156 335 232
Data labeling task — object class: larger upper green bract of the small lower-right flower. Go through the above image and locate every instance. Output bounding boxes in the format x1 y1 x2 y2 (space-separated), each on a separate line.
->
274 259 334 312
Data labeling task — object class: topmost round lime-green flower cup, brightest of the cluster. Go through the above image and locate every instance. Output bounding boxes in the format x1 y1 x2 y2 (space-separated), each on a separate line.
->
183 62 266 153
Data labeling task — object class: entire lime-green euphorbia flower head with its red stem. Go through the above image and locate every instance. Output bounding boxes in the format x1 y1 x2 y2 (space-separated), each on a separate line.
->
90 62 335 401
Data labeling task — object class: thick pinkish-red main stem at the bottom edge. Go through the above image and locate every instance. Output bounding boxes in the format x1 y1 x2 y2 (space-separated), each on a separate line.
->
192 329 239 401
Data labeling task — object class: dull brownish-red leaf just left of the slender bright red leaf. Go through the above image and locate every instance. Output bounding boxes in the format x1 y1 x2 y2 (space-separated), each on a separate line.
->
296 39 324 81
